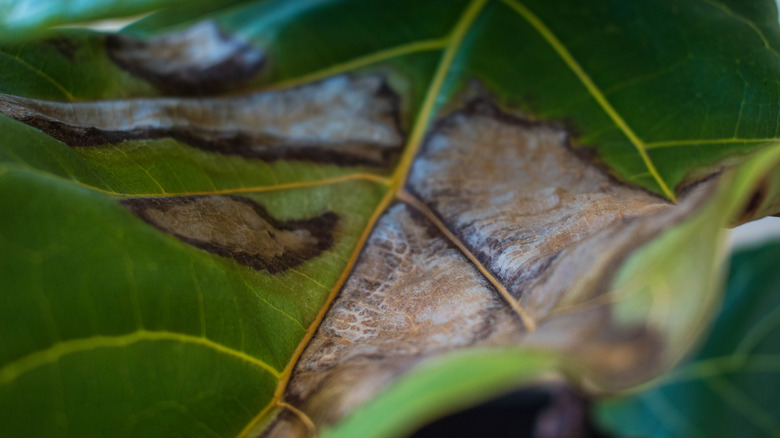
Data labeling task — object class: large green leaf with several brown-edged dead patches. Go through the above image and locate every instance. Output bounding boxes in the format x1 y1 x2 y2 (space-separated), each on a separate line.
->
0 0 780 436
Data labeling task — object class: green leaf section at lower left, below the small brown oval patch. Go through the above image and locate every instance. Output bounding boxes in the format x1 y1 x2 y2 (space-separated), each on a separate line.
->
0 163 381 436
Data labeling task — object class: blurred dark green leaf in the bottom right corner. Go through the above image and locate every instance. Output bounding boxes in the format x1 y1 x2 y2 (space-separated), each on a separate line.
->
598 242 780 437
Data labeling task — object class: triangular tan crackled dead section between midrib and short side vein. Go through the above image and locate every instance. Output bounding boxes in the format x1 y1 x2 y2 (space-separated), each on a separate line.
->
260 204 524 436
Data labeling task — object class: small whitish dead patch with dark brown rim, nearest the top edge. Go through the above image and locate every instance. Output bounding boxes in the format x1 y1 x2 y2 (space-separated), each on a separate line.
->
106 21 265 94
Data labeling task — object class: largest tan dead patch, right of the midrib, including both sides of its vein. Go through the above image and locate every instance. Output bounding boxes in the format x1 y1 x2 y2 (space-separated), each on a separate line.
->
264 100 712 437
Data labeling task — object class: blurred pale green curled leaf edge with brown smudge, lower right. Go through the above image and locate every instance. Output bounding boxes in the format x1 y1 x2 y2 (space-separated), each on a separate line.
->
304 144 780 437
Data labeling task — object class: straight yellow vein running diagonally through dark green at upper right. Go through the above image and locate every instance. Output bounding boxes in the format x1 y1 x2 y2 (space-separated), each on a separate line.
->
501 0 677 202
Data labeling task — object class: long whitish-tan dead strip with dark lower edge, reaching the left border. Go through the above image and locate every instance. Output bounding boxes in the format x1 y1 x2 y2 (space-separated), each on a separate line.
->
0 75 404 167
